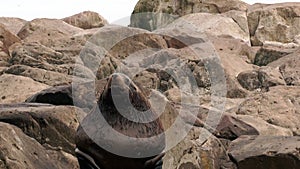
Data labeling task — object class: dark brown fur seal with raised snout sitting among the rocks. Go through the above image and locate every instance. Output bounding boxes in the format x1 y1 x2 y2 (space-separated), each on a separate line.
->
75 73 165 169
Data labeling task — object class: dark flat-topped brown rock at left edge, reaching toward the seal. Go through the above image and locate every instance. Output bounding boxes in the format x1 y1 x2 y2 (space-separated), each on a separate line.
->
0 105 85 154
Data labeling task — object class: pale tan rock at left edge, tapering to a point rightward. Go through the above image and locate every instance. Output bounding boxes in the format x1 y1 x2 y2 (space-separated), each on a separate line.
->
0 74 49 103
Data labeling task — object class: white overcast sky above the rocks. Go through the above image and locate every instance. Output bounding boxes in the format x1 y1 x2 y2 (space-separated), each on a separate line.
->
0 0 300 23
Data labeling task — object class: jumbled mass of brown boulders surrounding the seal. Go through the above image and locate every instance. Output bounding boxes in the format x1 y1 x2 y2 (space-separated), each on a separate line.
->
0 0 300 169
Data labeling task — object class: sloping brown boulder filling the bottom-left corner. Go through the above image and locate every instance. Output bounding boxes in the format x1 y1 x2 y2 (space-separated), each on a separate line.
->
0 122 79 169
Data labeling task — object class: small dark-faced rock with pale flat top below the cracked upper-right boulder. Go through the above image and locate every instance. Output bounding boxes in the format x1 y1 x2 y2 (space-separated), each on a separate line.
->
252 46 295 66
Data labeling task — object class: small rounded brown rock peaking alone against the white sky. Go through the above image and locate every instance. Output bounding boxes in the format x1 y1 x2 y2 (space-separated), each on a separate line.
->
62 11 108 29
